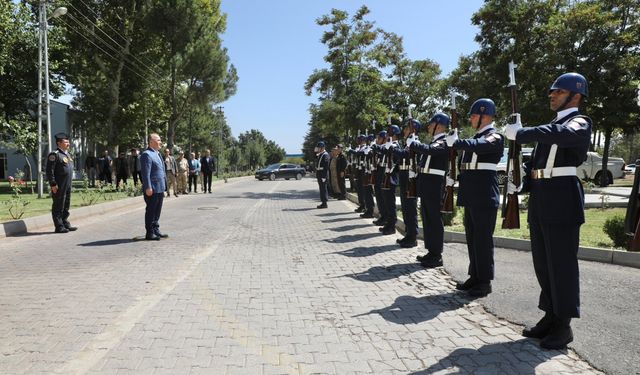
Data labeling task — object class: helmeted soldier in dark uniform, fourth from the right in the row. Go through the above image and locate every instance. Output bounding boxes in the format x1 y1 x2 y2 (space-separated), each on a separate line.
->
394 118 422 248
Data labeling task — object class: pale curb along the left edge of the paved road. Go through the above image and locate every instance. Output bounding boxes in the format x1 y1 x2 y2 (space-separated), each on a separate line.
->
0 176 254 238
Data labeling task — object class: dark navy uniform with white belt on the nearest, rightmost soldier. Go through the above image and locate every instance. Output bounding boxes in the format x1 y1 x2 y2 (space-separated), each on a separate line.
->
516 108 591 318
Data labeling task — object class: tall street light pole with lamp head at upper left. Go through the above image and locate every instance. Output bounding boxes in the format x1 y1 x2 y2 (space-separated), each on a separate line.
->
37 0 67 198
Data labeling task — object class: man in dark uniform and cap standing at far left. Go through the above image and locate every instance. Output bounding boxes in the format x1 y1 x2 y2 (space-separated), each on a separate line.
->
47 133 78 233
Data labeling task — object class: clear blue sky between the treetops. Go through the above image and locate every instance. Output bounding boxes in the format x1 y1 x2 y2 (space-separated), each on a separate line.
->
222 0 483 154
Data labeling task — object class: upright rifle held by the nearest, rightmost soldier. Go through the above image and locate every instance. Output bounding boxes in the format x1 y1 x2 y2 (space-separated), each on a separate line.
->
502 61 522 229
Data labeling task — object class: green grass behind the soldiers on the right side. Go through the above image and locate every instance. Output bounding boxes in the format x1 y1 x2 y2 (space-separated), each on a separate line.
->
445 208 626 248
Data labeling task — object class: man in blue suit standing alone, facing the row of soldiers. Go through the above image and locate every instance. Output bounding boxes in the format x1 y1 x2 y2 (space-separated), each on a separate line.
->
140 133 168 241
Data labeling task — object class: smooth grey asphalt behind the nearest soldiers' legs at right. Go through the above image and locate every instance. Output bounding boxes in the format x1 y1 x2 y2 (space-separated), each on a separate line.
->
444 244 640 375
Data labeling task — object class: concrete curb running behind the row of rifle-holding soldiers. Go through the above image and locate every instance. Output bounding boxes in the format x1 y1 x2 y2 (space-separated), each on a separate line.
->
347 193 640 268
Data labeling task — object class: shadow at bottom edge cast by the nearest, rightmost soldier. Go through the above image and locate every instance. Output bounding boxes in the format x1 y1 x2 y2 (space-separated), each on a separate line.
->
408 339 566 375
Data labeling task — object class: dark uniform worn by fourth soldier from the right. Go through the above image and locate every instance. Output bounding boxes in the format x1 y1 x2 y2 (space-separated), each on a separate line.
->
394 137 418 243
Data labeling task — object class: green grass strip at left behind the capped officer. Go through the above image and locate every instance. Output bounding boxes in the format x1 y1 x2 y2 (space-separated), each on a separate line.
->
0 181 128 222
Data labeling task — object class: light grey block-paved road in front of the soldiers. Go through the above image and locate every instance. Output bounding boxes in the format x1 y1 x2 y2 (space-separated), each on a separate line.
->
0 179 598 374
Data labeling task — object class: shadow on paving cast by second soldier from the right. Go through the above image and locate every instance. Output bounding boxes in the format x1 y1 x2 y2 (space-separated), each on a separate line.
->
356 292 470 325
